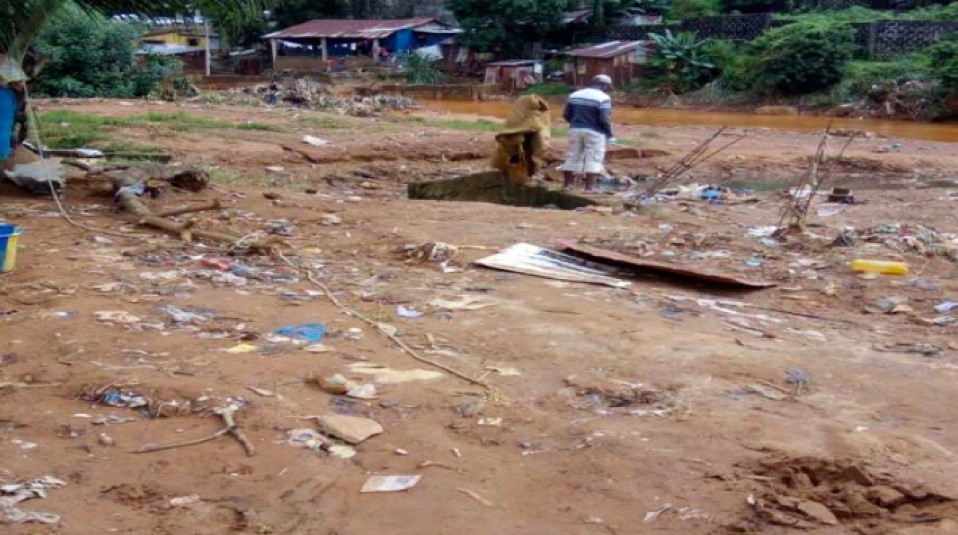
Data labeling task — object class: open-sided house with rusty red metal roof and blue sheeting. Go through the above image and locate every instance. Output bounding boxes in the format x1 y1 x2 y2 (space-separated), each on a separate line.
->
264 18 461 71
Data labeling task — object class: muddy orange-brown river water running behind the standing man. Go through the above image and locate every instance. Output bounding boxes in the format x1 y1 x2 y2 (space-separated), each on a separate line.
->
423 100 958 142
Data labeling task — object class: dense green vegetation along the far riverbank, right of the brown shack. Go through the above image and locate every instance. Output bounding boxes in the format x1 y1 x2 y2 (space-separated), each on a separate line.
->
632 3 958 119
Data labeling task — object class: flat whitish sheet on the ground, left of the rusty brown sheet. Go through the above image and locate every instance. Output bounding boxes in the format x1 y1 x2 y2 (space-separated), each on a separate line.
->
476 243 631 288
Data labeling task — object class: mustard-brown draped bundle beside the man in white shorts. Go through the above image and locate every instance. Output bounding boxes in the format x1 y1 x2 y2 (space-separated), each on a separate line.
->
492 95 552 186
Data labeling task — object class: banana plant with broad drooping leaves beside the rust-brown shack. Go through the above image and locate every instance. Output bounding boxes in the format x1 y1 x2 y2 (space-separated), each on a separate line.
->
649 30 715 93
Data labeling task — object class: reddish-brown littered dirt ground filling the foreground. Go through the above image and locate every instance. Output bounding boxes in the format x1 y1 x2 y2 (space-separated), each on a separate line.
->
0 98 958 535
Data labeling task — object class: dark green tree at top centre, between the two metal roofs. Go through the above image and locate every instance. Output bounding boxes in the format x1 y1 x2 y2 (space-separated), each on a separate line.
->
448 0 577 55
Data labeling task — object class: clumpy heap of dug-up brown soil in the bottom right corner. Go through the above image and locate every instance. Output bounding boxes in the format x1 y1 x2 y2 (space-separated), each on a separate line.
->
731 457 958 534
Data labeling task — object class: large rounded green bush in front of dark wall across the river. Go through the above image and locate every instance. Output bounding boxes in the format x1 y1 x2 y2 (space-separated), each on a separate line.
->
748 21 855 95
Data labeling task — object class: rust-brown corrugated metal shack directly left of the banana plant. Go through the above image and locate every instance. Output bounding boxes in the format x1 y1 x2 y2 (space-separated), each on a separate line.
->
565 41 650 87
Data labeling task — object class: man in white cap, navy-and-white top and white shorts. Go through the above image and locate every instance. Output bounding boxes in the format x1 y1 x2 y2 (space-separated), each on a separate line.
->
562 74 615 193
